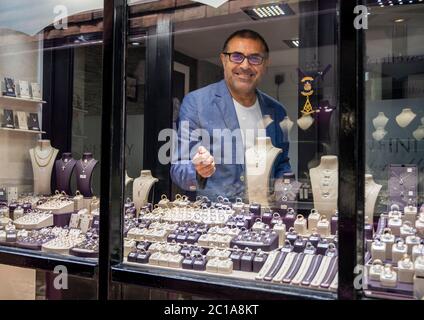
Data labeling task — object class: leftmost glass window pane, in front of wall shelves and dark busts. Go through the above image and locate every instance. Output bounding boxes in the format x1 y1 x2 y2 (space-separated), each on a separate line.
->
0 1 103 298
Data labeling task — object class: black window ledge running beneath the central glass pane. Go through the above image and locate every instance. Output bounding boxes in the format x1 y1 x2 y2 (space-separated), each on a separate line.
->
112 263 336 300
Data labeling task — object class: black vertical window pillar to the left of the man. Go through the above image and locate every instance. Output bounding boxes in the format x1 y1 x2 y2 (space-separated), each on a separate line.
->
99 0 127 300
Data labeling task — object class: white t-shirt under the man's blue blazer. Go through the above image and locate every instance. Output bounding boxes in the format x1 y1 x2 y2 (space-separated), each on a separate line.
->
233 99 264 150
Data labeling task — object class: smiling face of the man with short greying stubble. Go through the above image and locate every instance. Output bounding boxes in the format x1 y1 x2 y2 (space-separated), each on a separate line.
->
221 37 268 95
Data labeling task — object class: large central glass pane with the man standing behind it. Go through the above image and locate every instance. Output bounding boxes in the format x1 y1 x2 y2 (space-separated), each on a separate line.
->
123 1 338 295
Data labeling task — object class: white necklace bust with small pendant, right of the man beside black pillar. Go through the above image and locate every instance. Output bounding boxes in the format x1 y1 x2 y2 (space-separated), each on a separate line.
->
309 156 339 220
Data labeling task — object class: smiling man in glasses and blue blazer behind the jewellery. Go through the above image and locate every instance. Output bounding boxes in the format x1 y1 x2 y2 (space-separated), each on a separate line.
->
171 30 291 201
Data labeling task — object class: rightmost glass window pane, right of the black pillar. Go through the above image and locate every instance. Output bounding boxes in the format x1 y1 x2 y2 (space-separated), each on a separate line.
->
365 1 424 299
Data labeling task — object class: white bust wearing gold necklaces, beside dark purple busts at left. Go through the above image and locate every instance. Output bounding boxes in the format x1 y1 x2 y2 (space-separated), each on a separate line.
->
29 140 59 195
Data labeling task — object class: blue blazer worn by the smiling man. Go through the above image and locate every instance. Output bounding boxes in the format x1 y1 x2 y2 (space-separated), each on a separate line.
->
171 80 291 201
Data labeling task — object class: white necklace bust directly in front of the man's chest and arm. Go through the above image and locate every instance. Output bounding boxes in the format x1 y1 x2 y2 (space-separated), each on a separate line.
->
246 137 283 206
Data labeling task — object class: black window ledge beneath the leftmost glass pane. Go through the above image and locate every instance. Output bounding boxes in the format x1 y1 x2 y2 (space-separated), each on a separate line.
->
0 246 98 278
